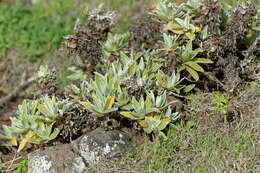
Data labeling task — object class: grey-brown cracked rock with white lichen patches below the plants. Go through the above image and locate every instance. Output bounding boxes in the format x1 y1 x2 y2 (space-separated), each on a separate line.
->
28 129 131 173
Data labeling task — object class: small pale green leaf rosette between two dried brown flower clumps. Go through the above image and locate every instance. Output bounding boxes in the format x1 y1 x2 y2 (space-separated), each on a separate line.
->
100 33 128 58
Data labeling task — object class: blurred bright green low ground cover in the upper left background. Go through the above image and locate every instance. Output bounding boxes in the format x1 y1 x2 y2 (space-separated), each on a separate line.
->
0 0 74 60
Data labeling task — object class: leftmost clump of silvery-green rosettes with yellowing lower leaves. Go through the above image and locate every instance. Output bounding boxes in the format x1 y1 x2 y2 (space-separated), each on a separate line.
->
0 96 70 152
